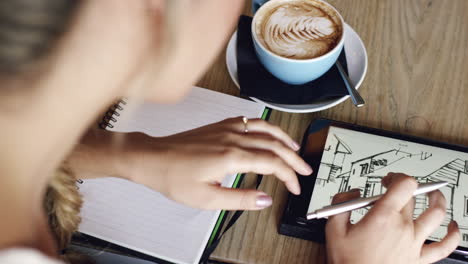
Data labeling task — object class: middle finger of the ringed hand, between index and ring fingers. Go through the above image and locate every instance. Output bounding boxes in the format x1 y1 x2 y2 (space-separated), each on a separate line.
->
226 133 312 175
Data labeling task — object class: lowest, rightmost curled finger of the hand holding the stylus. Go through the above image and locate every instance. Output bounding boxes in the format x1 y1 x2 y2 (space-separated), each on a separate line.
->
420 221 460 263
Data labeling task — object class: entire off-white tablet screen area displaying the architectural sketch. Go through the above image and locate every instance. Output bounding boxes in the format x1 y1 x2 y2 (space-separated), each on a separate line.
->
308 127 468 247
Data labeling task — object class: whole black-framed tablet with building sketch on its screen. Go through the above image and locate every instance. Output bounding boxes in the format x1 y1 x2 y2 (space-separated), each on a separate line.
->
279 119 468 260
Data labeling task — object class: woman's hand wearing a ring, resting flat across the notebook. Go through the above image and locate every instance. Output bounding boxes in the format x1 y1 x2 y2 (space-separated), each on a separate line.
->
129 117 312 210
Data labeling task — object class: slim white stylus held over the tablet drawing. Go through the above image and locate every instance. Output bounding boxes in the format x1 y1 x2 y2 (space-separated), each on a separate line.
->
307 181 448 220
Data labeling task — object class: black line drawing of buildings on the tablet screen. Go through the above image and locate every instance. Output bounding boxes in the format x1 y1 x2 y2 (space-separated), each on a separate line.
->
315 134 468 246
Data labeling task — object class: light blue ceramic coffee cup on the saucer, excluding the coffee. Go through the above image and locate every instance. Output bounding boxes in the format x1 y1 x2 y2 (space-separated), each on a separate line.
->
251 0 344 85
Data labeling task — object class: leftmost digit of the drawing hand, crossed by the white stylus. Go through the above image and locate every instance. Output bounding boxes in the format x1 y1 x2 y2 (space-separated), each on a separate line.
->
326 189 360 237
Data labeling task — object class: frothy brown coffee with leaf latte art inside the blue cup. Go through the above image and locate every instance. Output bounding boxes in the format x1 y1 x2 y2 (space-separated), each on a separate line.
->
255 0 342 59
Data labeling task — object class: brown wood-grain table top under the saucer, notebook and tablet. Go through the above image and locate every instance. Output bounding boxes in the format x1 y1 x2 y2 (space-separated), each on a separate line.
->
198 0 468 264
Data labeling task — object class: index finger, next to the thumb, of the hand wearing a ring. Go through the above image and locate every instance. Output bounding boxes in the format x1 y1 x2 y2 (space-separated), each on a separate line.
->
220 148 301 194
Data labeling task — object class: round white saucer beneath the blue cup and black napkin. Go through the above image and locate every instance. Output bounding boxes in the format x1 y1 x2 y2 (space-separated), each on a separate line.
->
226 24 367 113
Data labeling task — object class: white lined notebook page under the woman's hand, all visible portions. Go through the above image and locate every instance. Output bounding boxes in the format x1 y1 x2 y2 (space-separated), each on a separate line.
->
79 87 264 263
